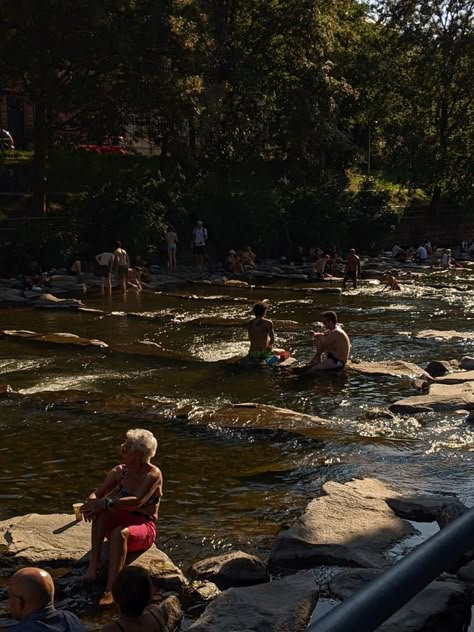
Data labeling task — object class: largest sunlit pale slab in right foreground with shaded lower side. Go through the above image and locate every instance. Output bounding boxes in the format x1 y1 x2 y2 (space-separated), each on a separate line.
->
269 479 415 570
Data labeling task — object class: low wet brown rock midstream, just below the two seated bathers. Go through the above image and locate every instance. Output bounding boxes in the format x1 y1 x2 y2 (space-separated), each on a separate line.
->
190 402 330 438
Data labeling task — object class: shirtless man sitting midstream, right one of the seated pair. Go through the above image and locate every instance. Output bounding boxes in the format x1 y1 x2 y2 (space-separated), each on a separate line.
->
306 312 351 371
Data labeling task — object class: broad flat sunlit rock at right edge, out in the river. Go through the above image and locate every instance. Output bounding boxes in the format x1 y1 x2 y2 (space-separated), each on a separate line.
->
390 382 474 414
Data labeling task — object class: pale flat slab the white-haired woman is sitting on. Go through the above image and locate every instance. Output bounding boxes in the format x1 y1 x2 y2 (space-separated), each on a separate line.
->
0 514 186 590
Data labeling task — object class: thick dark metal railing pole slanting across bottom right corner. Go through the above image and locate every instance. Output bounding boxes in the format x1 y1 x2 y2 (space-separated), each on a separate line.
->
307 508 474 632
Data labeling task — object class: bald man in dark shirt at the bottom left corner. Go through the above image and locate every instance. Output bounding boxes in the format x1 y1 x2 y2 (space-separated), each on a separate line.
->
8 567 86 632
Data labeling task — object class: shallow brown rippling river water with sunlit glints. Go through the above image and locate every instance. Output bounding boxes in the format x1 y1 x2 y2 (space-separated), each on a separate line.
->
0 273 474 569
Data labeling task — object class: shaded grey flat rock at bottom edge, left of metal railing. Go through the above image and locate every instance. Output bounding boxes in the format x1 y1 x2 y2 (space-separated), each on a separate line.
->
188 572 318 632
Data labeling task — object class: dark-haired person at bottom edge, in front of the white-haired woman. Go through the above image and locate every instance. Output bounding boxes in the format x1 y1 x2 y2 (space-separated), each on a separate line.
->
102 566 181 632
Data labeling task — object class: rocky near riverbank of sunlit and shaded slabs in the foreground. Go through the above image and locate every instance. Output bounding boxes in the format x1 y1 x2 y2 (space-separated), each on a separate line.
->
0 479 474 632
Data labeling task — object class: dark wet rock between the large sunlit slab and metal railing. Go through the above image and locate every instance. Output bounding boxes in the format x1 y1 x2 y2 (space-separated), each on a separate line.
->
387 494 467 526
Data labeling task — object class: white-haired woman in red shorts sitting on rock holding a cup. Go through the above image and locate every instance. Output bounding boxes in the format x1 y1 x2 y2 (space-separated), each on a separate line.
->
82 428 163 605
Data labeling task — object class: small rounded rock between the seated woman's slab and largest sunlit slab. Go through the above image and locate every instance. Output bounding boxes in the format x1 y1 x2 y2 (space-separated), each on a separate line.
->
189 551 269 590
